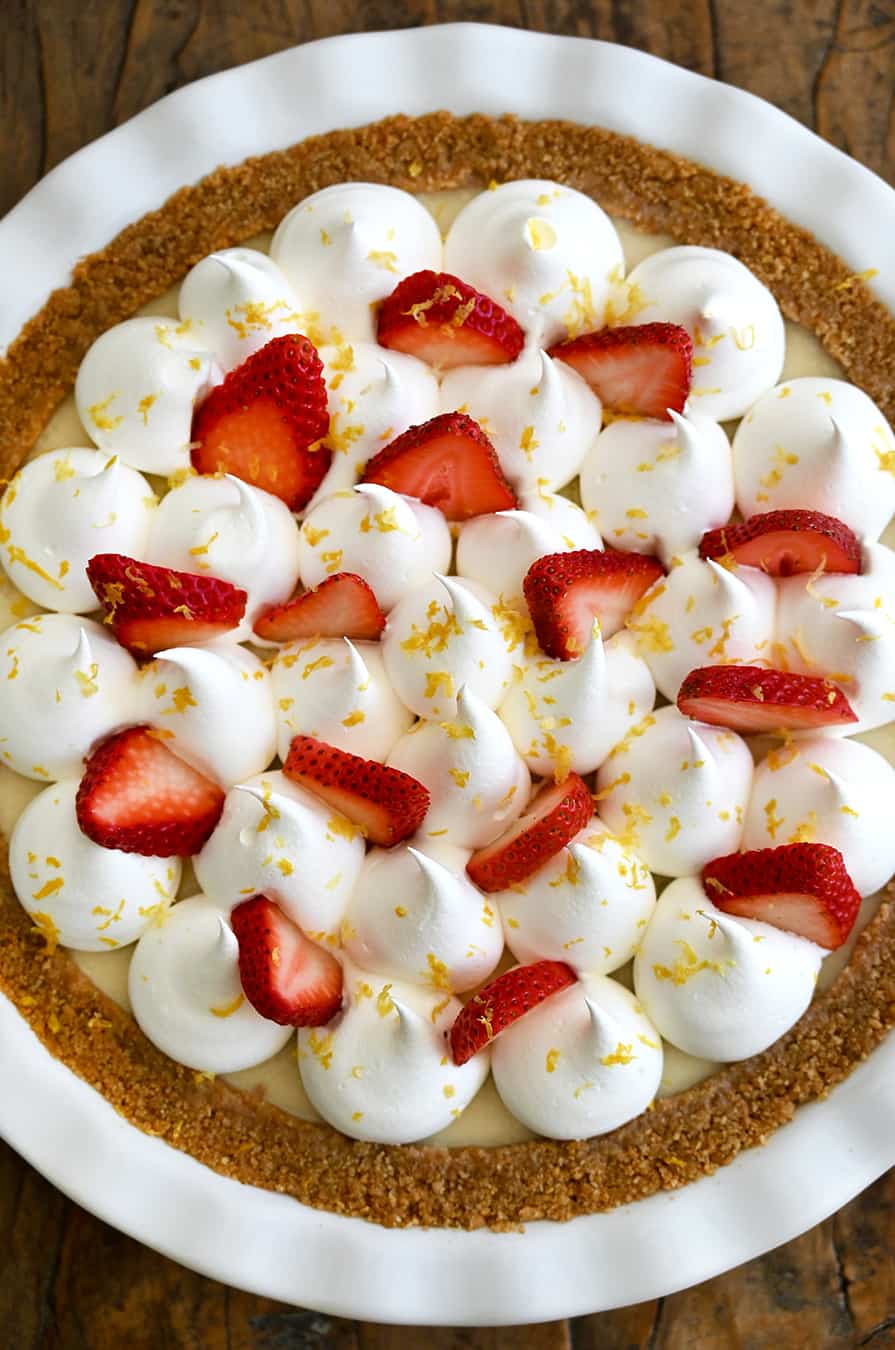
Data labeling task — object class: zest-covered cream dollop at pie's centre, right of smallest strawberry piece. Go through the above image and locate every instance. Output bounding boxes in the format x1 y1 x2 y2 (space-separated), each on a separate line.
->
382 575 512 721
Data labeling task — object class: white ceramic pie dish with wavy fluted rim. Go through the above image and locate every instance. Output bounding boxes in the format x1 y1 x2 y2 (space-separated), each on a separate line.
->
0 24 895 1324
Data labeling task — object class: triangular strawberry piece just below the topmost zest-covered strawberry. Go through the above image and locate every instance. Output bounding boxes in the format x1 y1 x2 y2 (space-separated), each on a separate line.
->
363 413 518 520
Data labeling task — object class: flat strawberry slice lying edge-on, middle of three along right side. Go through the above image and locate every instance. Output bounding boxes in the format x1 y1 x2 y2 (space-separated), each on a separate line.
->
678 666 857 734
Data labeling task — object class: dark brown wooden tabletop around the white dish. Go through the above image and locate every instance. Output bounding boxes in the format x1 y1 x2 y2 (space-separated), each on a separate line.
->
0 0 895 1350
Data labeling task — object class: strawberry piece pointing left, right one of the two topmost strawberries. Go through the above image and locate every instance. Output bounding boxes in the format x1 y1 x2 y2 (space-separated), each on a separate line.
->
549 324 693 419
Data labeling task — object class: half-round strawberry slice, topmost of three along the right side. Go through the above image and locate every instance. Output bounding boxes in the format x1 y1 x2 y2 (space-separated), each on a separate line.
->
699 510 861 576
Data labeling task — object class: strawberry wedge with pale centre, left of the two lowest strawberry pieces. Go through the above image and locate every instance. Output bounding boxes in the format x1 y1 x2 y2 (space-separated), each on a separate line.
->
229 895 342 1026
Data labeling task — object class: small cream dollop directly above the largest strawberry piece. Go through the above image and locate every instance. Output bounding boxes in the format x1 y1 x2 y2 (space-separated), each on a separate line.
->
178 248 302 371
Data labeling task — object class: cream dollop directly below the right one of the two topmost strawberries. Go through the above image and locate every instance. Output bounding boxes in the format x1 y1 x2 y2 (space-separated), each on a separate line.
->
580 412 733 566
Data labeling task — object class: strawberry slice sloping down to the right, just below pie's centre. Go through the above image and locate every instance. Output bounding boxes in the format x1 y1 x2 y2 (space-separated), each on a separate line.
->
283 736 429 848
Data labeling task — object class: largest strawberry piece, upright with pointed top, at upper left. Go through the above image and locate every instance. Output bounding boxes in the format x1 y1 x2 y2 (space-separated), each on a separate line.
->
192 333 332 510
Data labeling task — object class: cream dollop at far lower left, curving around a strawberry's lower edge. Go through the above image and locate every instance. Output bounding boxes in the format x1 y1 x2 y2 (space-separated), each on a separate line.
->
9 778 181 952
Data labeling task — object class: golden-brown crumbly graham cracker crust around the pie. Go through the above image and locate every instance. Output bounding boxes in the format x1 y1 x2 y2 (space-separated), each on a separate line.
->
0 112 895 1229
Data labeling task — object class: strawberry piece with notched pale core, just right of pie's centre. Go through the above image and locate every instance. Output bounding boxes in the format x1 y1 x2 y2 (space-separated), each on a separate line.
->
522 548 664 662
